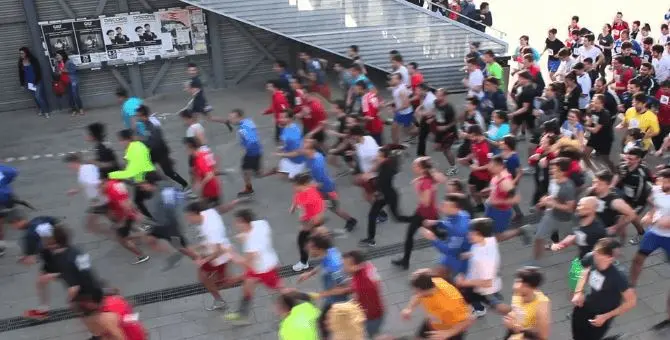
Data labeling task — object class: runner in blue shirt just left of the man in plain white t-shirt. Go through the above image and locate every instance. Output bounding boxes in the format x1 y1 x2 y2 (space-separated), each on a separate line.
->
421 193 471 280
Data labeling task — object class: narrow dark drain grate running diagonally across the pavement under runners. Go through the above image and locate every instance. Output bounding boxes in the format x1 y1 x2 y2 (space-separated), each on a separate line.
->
0 215 539 333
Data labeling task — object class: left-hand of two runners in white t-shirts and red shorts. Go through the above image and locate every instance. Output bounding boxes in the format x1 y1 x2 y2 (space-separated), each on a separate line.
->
185 202 230 311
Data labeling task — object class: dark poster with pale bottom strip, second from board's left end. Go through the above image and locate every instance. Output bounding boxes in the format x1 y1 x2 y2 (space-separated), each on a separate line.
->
72 19 107 68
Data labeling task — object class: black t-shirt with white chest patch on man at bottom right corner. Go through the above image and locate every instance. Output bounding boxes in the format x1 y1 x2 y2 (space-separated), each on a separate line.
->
582 253 630 315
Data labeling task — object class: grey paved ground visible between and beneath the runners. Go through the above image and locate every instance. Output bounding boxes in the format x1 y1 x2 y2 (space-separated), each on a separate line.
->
0 75 670 340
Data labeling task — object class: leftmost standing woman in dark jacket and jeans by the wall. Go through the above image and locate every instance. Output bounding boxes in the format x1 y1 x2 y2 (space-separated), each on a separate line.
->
18 47 51 118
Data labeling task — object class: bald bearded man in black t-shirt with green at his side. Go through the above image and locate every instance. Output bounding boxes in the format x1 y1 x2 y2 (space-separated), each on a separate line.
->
551 196 607 292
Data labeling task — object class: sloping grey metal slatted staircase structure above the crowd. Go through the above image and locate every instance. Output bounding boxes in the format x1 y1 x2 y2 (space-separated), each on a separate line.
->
181 0 507 90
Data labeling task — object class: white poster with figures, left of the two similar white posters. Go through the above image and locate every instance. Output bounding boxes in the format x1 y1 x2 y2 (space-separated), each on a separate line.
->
100 14 137 65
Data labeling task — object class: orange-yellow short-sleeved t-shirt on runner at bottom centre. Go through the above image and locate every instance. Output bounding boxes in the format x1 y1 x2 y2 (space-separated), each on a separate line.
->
419 278 471 330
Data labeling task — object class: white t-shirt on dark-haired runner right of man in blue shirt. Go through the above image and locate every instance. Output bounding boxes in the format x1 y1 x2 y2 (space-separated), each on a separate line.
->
467 237 502 295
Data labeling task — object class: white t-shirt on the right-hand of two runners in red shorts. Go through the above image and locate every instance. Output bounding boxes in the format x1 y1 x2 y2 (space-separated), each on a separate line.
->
243 220 279 274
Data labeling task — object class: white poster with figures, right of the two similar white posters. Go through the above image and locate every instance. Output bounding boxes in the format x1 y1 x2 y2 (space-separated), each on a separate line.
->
130 13 163 62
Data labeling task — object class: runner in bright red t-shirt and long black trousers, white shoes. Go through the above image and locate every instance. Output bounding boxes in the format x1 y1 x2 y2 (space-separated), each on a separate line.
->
289 173 326 272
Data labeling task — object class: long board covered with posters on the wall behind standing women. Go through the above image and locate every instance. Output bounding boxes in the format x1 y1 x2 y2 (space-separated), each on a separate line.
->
39 7 207 69
